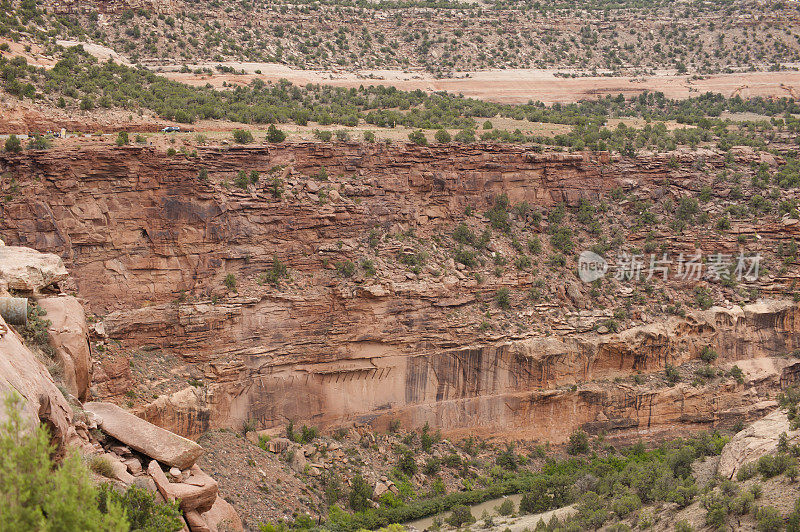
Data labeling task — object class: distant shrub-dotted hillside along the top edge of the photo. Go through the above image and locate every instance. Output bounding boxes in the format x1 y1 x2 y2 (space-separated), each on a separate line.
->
0 0 800 76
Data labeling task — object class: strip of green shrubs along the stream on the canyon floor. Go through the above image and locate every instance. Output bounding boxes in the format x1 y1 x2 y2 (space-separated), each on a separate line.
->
308 433 727 531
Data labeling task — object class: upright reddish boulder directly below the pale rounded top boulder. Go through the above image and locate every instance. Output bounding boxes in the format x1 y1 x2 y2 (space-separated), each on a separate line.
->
38 296 92 401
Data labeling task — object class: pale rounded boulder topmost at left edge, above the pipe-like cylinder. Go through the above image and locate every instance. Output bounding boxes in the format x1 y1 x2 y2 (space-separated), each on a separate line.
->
0 246 68 293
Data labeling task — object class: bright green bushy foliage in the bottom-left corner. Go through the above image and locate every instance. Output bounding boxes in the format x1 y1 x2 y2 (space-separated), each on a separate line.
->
0 394 183 532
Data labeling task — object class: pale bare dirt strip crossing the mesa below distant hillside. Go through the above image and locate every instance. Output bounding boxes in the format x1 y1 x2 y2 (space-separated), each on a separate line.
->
164 63 800 104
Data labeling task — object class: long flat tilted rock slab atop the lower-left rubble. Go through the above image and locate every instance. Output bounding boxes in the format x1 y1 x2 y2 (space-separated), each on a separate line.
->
84 402 203 469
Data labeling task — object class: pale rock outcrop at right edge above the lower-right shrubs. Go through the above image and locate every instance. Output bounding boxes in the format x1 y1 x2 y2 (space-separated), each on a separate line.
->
717 410 800 478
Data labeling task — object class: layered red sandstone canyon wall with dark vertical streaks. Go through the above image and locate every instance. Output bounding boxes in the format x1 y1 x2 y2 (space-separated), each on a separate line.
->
0 143 800 441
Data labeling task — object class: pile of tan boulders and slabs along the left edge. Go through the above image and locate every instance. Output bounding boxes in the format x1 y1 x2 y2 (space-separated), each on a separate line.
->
0 241 243 532
